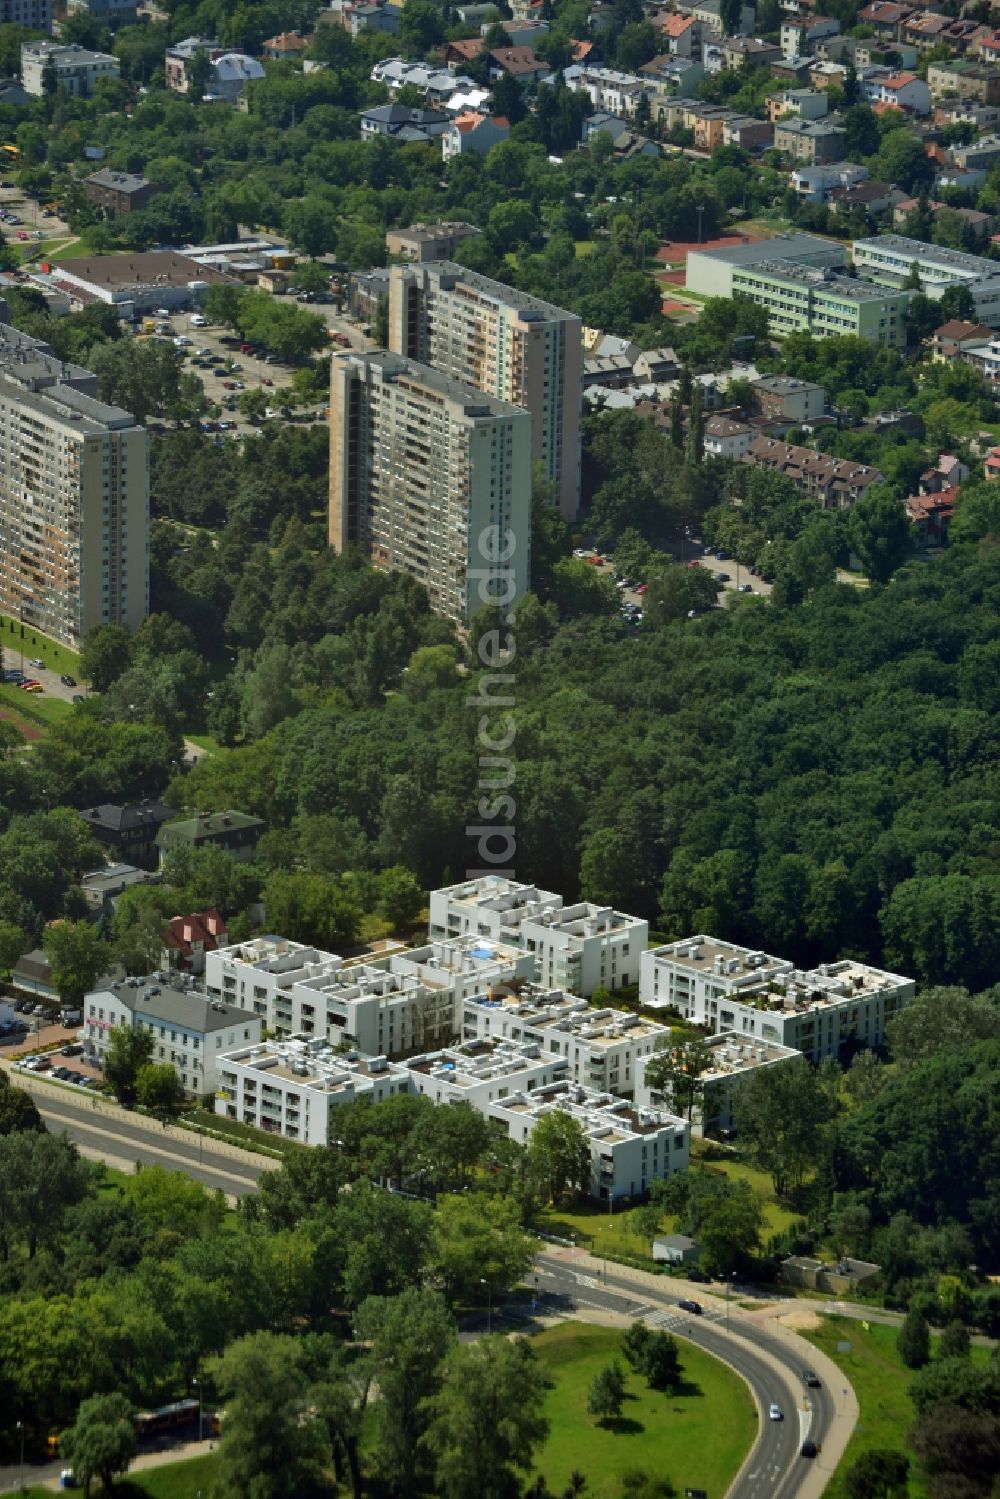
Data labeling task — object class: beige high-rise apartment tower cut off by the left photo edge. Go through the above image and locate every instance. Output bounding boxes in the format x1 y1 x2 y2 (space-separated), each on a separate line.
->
0 316 150 648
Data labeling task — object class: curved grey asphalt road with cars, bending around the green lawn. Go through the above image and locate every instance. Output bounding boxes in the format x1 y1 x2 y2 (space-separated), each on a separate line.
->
535 1252 835 1499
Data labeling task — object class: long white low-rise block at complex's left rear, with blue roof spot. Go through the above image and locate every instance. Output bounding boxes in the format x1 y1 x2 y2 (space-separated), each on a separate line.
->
205 937 534 1057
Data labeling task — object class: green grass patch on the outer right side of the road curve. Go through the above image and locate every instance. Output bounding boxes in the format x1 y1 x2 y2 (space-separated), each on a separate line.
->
802 1316 990 1499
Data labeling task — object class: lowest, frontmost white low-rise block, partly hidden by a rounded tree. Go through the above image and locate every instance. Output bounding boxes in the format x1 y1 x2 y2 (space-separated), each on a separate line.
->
486 1082 691 1202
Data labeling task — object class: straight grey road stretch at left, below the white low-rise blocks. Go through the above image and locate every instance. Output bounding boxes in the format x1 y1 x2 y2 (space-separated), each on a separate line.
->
31 1084 267 1198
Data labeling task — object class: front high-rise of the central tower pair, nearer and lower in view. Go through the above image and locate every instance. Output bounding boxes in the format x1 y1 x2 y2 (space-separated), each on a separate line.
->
330 352 531 624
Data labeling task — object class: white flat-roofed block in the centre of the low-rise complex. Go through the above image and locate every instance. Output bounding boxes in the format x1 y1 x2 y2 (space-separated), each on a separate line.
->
462 983 670 1097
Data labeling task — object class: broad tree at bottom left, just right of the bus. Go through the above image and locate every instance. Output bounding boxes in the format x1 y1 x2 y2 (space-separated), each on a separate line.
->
213 1333 330 1499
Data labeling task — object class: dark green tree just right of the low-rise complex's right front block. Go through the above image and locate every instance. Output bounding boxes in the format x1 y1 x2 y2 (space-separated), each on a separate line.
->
732 1060 829 1196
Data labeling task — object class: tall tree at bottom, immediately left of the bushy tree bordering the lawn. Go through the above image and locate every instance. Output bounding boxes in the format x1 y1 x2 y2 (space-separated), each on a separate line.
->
354 1288 456 1493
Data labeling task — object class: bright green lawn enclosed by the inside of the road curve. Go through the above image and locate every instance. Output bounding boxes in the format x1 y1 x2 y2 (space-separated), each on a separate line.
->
532 1322 757 1499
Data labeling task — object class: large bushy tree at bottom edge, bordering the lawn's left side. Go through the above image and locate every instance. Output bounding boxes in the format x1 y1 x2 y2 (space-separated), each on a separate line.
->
426 1337 549 1499
